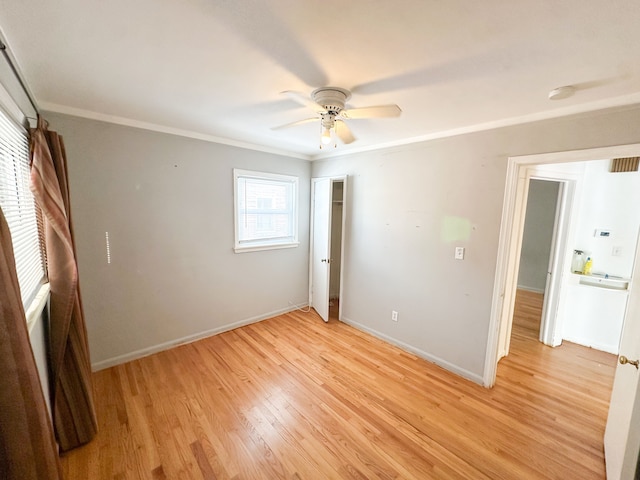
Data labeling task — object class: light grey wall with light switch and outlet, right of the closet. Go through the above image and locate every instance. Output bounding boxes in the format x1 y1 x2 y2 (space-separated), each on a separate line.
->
312 108 640 383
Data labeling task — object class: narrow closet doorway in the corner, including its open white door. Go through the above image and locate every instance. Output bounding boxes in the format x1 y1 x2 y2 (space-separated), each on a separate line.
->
309 176 347 322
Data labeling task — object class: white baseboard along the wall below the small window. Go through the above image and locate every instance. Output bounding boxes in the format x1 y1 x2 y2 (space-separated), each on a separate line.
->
91 305 308 372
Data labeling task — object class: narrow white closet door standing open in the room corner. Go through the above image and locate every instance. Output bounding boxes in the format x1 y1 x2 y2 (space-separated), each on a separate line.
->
310 178 332 322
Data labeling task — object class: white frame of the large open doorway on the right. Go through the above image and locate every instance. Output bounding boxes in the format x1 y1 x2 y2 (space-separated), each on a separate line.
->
483 143 640 387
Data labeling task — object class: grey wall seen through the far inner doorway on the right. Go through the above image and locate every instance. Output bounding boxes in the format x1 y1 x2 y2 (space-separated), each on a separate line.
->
518 179 559 293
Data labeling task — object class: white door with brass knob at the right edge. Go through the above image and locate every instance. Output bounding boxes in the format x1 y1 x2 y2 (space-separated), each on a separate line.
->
604 234 640 480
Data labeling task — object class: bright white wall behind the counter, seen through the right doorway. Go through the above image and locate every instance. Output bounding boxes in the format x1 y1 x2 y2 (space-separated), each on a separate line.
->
558 160 640 354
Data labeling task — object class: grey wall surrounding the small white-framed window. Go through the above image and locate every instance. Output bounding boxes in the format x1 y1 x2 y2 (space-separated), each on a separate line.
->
45 113 310 368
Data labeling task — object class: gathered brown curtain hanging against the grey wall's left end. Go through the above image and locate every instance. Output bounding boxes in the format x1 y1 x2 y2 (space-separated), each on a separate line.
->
31 117 97 452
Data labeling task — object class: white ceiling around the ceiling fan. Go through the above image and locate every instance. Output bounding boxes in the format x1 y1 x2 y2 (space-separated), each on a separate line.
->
0 0 640 158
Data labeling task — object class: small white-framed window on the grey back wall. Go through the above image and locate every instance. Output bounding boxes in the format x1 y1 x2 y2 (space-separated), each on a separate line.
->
233 169 298 252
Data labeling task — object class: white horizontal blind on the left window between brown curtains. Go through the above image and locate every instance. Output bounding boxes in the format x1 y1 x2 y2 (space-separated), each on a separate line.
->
0 110 45 308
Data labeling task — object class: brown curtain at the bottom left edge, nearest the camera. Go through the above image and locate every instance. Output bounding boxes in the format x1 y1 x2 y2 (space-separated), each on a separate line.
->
0 210 62 480
